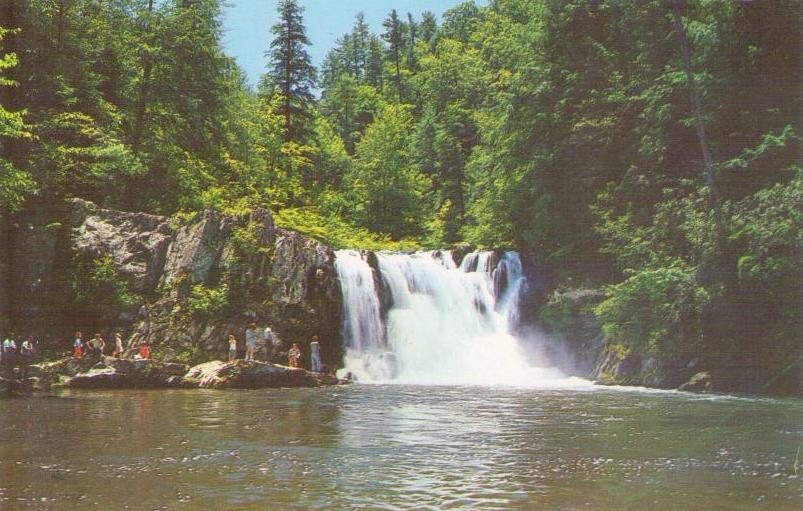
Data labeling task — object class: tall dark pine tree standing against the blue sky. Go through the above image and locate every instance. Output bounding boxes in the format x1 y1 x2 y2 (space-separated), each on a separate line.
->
267 0 315 141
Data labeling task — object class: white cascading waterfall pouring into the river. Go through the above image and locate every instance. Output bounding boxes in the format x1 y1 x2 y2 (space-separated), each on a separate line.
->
335 250 590 387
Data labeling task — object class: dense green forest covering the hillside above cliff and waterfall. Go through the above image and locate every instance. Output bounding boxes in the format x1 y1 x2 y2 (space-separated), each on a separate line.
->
0 0 803 392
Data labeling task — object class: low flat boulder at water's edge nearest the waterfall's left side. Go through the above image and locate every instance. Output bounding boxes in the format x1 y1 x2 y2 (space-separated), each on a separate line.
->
184 360 339 389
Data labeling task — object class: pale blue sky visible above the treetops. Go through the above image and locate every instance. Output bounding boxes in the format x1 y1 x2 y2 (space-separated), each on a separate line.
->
223 0 487 86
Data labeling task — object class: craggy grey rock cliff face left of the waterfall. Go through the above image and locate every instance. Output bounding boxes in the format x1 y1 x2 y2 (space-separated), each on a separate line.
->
7 199 341 372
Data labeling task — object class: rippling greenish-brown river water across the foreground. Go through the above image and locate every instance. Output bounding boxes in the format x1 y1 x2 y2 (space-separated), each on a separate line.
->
0 384 803 511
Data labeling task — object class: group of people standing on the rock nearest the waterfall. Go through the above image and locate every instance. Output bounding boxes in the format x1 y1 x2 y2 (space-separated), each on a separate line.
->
227 322 323 373
